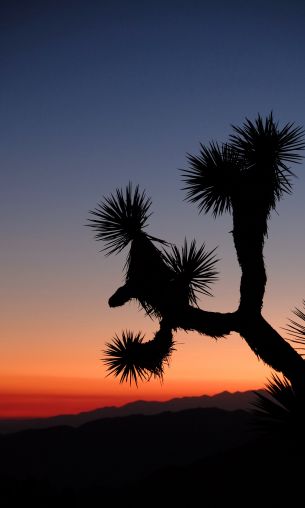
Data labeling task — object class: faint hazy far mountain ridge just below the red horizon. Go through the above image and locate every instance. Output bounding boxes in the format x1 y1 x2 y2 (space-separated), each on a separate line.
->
0 390 263 433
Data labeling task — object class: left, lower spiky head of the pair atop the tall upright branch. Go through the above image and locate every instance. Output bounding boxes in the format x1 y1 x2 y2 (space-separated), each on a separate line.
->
182 142 241 217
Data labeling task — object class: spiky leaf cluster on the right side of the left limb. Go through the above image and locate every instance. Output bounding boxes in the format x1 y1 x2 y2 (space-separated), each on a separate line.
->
165 239 218 305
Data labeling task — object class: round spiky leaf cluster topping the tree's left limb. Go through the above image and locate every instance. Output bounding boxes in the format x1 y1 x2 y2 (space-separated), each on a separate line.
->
88 183 151 254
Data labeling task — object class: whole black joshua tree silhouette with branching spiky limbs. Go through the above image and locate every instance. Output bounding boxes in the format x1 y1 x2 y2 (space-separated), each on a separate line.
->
88 113 305 393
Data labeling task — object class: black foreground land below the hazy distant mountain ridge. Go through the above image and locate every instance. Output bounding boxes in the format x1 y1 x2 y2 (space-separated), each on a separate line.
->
0 400 305 508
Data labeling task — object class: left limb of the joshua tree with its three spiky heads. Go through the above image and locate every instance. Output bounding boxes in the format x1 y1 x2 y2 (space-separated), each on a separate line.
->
89 184 217 384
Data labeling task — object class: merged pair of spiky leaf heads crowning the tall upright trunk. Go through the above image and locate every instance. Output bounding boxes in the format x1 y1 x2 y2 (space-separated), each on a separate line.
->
183 113 305 219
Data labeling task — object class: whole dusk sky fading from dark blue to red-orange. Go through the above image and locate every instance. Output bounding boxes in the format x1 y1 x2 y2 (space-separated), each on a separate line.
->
0 0 305 417
